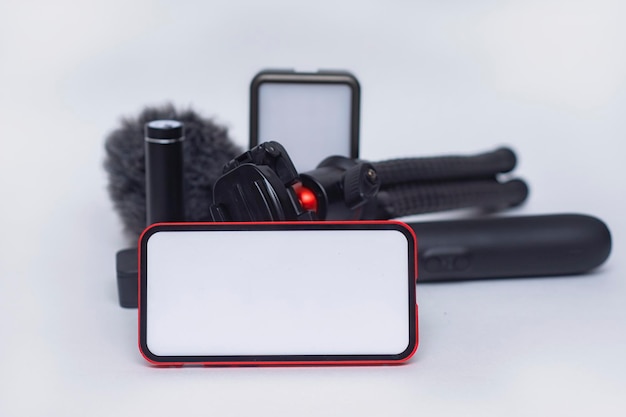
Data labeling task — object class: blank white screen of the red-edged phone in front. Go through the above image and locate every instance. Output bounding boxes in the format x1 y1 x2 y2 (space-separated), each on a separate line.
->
146 230 409 356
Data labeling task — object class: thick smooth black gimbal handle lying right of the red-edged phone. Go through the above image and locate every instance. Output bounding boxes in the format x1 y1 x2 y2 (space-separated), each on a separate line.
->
409 214 611 282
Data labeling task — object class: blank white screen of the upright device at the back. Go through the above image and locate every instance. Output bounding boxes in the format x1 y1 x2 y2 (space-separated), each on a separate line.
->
258 83 352 172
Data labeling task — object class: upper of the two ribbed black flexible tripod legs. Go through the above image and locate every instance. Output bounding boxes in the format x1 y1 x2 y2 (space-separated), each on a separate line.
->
374 148 517 186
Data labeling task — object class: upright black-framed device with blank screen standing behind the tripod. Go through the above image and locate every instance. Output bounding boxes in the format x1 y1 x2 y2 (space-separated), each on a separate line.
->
250 70 360 172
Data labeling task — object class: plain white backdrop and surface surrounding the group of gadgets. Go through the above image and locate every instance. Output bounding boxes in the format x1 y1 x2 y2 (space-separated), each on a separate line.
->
0 0 626 416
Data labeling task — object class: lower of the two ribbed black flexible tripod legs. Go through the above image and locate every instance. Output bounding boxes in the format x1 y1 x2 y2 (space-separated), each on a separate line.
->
376 179 528 219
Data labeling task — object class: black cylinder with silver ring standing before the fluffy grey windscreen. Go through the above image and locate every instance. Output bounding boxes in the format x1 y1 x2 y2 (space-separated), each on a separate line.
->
145 120 185 226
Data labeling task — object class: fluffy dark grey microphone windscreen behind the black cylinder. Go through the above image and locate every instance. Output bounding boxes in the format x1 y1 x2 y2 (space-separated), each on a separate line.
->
104 104 242 240
